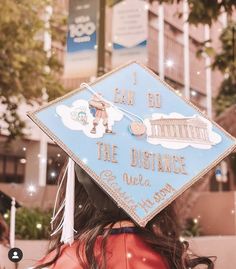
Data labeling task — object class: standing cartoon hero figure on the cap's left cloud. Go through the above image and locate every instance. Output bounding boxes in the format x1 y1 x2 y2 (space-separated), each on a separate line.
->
89 94 112 134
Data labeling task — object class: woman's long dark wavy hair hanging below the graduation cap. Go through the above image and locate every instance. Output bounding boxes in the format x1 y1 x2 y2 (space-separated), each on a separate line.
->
35 163 214 269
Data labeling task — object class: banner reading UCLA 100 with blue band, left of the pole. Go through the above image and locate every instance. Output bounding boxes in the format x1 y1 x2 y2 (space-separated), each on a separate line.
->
64 0 98 78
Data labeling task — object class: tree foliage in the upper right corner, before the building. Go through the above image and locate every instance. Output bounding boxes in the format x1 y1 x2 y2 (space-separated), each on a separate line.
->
151 0 236 114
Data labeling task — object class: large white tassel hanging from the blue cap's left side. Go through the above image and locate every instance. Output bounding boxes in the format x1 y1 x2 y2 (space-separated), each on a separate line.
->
61 158 75 245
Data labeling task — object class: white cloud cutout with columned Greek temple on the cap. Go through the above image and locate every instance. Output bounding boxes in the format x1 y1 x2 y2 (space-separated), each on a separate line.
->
144 113 222 149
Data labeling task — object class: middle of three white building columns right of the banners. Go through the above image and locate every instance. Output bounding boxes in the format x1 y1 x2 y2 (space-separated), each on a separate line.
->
183 0 190 99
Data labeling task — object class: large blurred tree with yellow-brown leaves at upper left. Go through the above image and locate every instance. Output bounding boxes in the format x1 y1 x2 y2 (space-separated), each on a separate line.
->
0 0 65 138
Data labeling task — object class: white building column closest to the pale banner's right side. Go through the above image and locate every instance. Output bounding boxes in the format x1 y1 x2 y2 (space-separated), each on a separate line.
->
158 5 165 80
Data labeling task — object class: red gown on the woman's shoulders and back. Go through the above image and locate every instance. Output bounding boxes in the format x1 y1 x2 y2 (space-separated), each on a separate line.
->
39 233 169 269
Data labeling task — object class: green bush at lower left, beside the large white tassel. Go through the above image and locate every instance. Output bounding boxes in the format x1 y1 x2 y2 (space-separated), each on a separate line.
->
6 207 52 240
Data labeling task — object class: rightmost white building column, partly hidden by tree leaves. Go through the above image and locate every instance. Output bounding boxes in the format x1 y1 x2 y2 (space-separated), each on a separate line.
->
204 25 212 118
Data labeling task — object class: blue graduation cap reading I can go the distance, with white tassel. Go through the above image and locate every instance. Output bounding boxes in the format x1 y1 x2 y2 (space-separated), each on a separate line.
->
29 62 236 243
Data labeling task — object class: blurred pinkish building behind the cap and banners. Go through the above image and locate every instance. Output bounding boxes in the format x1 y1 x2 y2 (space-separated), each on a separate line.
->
0 0 233 199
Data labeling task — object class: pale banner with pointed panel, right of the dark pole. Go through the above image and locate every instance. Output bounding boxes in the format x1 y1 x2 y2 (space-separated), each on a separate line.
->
112 0 148 68
